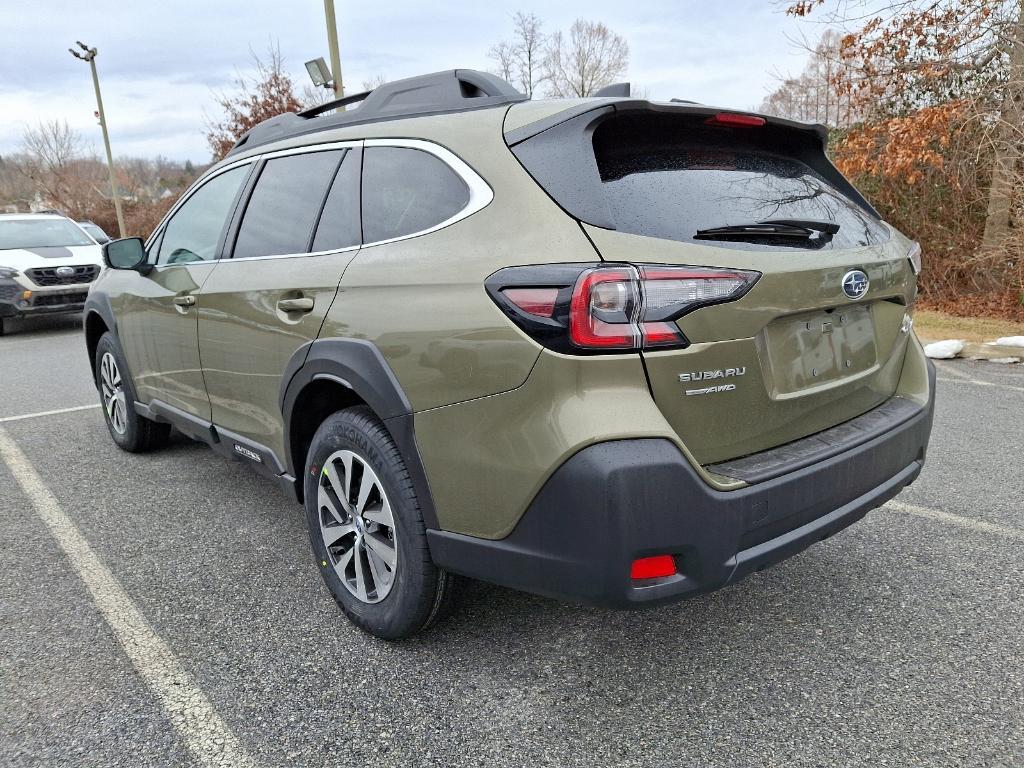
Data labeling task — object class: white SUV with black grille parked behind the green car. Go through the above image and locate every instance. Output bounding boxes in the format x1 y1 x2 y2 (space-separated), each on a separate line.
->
0 213 103 336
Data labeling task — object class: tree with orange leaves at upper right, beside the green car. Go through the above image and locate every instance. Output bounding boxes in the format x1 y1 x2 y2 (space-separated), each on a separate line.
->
787 0 1024 256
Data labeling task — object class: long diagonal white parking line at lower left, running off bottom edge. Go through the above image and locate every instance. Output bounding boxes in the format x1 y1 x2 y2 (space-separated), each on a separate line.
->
0 427 254 767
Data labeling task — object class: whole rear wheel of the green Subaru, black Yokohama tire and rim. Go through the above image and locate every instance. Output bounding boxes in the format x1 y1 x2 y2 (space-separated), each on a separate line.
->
304 406 456 640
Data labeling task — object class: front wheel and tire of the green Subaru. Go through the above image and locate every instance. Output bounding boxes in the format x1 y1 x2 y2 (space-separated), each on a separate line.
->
95 331 171 454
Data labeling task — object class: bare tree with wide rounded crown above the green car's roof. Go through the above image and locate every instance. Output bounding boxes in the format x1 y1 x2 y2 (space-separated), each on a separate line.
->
545 18 630 96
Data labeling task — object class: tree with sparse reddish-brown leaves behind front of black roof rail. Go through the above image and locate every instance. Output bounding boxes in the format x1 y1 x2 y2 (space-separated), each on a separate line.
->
206 45 302 160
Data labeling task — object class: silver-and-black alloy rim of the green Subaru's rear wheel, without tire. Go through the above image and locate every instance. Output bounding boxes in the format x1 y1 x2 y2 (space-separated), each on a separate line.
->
316 451 398 603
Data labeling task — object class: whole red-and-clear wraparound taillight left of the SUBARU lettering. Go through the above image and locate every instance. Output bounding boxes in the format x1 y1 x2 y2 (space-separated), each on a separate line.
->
486 264 761 354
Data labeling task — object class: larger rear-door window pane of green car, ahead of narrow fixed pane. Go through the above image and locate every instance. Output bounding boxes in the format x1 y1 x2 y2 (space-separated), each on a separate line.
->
233 150 345 259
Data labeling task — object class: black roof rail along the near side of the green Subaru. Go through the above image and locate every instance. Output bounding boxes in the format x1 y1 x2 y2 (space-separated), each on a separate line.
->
227 70 527 157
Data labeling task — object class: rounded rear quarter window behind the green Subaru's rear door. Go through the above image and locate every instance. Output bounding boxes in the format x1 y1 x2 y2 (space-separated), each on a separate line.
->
362 146 469 243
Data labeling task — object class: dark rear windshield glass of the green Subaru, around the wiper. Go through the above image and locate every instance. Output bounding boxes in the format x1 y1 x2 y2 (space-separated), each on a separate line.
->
594 115 889 250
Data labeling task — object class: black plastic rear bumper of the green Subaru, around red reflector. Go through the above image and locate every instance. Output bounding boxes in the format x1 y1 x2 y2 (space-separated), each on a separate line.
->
428 367 935 607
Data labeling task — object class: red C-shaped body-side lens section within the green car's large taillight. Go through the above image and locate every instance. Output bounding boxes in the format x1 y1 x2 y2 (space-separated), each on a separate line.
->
569 267 640 349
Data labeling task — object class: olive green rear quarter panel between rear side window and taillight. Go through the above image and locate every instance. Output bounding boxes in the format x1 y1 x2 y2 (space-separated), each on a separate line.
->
321 110 598 411
